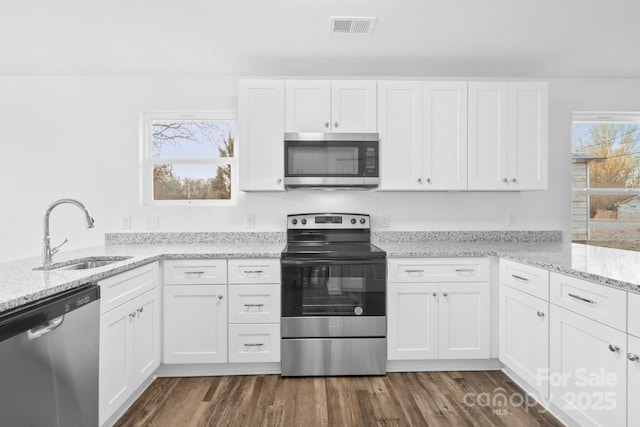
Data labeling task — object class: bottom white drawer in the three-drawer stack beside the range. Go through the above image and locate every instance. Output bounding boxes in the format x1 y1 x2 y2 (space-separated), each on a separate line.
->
229 324 280 363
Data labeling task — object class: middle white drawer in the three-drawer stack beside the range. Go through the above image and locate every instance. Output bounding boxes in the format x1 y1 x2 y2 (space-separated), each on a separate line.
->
229 285 280 323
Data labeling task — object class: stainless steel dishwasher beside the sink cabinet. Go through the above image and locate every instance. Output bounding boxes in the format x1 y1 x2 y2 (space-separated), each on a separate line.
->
0 284 100 427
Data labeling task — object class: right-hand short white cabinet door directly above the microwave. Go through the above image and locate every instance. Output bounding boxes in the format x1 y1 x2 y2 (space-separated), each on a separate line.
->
331 80 378 132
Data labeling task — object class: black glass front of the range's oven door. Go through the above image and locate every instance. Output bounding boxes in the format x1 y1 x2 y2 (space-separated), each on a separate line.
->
282 264 386 317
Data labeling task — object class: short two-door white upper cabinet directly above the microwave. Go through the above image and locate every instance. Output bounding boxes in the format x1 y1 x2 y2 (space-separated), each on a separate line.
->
285 80 378 132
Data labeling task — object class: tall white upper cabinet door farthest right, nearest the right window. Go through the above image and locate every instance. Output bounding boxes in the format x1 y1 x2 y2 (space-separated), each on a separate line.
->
508 82 549 190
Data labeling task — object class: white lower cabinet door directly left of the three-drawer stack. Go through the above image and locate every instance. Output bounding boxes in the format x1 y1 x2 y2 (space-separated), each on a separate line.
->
164 285 227 363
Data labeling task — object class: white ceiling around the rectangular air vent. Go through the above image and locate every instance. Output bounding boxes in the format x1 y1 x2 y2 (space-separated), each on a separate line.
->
0 0 640 78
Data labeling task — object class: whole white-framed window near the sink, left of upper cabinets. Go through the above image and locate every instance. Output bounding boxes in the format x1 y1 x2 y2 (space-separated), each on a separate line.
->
141 111 237 206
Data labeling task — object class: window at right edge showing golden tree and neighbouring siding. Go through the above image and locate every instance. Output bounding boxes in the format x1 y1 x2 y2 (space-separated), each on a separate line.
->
572 113 640 251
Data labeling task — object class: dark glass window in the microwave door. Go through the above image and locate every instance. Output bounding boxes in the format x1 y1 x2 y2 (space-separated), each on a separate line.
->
287 145 360 176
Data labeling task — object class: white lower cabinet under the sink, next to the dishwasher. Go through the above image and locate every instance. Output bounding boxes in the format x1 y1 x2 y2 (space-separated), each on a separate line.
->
99 263 160 425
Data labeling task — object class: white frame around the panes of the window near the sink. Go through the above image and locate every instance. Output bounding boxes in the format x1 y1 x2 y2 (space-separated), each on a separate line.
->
139 110 239 207
